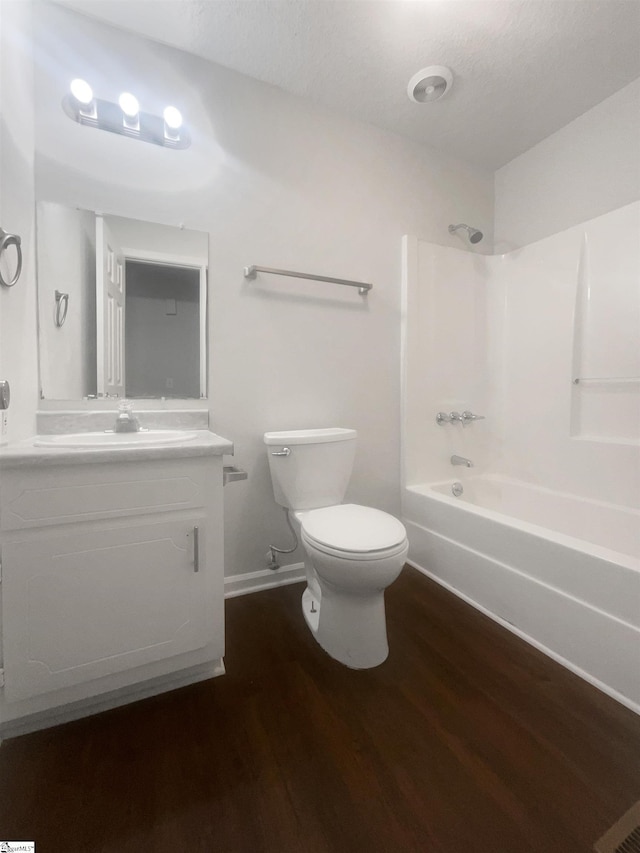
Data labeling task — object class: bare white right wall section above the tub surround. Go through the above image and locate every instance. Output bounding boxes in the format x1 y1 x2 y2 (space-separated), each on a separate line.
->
494 79 640 252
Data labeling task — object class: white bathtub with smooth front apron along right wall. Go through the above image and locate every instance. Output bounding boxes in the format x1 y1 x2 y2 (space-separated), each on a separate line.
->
403 476 640 713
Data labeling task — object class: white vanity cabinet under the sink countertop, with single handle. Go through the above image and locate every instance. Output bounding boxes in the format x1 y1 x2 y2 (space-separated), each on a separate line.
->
0 442 228 726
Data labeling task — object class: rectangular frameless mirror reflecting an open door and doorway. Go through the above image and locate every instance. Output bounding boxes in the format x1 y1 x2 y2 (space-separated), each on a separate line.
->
36 201 209 400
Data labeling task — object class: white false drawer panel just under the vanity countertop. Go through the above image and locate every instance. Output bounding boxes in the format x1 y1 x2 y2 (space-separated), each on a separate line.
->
0 457 222 530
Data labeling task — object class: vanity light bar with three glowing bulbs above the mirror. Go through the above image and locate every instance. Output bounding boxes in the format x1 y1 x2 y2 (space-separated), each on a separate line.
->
62 78 191 148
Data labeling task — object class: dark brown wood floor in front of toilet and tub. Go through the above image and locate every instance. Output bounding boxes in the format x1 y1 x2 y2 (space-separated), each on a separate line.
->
0 568 640 853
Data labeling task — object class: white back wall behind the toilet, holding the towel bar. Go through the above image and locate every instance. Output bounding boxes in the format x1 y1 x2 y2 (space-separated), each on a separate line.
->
18 1 493 574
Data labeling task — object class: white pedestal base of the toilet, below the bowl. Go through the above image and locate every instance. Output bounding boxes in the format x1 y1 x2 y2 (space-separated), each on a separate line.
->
302 583 389 669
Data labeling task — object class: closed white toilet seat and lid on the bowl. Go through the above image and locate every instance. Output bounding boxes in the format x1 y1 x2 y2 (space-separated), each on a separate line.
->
297 504 407 560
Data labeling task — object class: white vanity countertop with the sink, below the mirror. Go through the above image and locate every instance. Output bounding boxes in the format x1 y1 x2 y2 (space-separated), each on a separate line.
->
0 430 233 469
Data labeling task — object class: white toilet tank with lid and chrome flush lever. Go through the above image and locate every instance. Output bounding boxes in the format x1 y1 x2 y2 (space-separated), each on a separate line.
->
264 427 358 510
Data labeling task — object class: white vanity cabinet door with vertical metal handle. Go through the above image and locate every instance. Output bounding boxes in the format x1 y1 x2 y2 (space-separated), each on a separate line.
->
2 514 213 702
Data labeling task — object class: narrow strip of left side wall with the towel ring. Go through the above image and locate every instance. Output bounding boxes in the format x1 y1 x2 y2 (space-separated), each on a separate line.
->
0 2 38 441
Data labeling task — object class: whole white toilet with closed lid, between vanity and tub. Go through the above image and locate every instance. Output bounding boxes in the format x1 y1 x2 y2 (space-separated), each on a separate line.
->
264 428 409 669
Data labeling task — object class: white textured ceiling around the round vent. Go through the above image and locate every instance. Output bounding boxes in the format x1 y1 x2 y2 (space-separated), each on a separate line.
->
61 0 640 169
